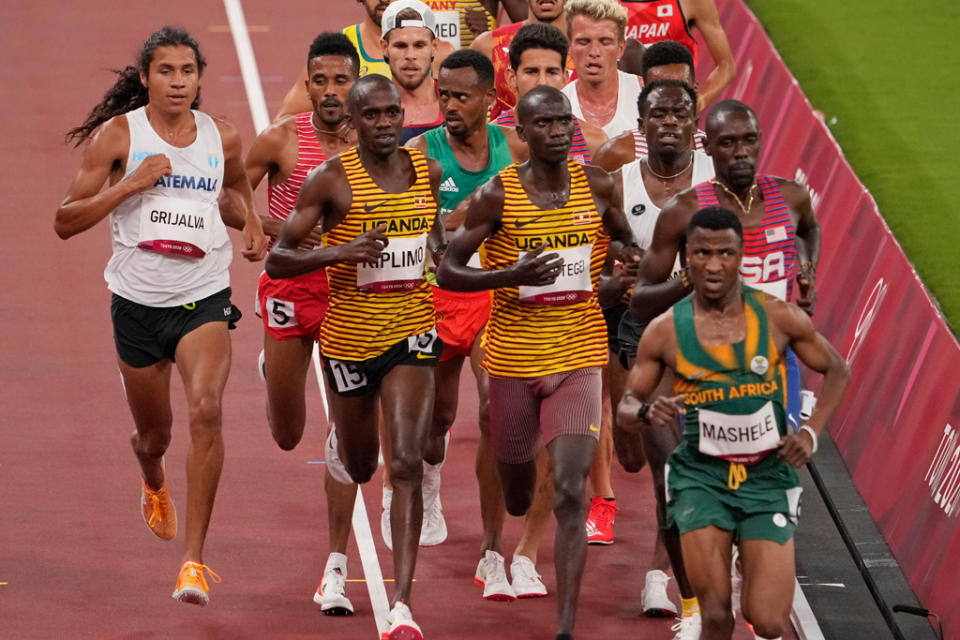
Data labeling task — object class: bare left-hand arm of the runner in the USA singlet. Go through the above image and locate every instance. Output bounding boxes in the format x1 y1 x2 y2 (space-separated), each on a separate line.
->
630 189 697 324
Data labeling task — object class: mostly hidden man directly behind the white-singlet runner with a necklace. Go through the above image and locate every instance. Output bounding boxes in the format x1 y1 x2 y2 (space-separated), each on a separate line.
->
593 40 703 174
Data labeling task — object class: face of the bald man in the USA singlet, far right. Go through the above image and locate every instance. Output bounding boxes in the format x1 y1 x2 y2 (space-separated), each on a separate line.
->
706 111 761 189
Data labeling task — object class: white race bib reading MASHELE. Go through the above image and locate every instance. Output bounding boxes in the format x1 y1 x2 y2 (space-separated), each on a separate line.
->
698 401 780 464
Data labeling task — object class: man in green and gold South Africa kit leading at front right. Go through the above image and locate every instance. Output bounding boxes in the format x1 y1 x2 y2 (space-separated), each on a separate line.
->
619 207 850 640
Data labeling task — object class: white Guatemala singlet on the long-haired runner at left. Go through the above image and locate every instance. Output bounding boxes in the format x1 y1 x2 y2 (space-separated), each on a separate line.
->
103 107 233 307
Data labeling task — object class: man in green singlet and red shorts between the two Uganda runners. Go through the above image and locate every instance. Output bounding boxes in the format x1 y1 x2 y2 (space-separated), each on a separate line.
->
409 49 512 556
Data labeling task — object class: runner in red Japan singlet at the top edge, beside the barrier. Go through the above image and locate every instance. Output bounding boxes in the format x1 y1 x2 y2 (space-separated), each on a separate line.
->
620 0 737 112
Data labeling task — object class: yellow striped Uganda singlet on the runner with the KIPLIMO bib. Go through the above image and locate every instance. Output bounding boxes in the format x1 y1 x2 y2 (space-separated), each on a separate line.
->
320 147 437 361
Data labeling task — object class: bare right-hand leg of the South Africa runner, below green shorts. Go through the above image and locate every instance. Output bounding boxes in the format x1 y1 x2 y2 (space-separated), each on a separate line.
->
740 538 794 638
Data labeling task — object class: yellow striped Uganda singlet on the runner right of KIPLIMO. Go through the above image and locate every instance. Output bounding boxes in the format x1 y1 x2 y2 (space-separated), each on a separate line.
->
483 159 610 378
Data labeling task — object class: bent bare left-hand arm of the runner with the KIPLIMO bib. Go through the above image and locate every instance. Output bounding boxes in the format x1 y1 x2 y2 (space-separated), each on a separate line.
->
266 158 387 278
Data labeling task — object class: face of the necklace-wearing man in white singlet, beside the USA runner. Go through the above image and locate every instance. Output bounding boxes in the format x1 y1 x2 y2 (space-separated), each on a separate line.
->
640 87 697 156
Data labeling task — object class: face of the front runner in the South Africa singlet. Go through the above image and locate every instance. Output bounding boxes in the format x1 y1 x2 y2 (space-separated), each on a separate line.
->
686 227 743 300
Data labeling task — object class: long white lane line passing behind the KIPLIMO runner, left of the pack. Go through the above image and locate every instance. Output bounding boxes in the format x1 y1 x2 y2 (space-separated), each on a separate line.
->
223 0 390 640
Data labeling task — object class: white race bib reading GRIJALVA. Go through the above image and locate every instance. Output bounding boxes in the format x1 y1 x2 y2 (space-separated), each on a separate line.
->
137 193 219 258
